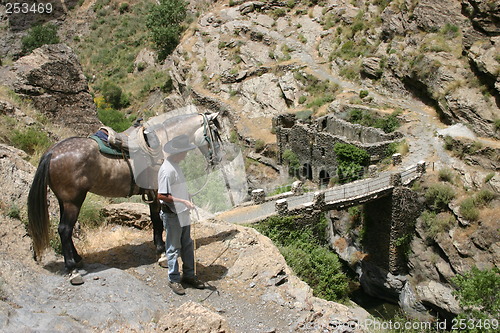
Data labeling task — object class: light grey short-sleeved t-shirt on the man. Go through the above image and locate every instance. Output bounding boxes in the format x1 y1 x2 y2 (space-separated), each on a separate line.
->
158 159 190 227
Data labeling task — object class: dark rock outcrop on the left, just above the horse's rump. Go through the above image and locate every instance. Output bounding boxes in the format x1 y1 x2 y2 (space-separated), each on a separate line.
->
0 44 101 136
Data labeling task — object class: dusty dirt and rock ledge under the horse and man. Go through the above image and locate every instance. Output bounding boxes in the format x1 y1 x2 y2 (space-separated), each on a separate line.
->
0 217 368 333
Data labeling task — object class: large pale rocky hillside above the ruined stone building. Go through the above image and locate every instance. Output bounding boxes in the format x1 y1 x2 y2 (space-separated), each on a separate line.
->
163 0 500 141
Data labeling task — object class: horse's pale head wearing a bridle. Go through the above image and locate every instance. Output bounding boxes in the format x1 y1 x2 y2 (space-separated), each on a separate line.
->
193 113 222 168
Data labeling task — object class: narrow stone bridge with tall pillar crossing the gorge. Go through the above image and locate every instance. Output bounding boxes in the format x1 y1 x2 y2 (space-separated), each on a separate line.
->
219 162 425 273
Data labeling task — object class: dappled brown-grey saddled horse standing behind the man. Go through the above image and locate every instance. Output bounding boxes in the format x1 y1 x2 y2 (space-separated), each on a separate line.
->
28 113 221 285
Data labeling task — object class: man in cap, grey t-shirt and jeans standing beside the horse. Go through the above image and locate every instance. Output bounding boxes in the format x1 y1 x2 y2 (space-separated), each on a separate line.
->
158 135 205 295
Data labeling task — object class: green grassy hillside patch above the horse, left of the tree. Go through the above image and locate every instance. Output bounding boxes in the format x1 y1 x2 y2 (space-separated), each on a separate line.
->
71 0 159 109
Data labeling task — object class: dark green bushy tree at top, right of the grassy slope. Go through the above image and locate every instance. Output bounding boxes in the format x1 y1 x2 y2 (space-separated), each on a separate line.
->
146 0 187 61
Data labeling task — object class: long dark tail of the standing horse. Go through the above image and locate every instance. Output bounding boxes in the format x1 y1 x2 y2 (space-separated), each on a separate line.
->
28 152 52 260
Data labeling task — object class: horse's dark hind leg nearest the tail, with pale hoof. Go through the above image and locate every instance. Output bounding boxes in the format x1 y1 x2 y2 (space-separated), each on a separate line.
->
58 200 83 284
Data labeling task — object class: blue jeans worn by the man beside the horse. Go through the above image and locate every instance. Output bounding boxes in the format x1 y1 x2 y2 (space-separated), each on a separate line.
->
160 211 194 282
